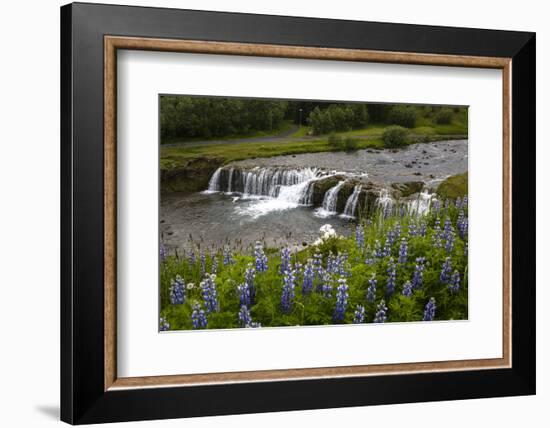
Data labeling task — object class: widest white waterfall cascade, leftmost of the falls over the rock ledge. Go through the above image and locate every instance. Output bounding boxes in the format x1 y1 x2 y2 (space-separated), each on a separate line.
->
206 167 327 205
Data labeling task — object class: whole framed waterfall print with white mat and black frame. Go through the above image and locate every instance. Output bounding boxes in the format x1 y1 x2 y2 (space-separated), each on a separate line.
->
61 3 535 424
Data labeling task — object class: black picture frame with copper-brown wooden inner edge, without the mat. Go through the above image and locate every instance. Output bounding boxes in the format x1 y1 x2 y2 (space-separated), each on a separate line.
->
61 4 535 424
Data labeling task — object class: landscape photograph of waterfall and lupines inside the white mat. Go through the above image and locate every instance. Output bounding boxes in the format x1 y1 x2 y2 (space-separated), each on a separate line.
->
159 94 468 331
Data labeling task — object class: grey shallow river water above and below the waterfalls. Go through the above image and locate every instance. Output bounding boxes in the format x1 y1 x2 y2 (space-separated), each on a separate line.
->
160 140 468 251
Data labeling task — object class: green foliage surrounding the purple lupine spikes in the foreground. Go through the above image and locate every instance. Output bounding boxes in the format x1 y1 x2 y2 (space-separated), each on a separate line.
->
160 203 468 330
